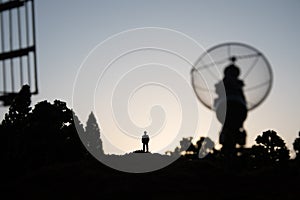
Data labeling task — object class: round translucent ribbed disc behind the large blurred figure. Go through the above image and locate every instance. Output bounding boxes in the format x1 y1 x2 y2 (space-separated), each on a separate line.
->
191 43 273 110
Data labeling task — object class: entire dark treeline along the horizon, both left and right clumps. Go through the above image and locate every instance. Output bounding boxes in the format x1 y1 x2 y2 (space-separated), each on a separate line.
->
0 86 300 189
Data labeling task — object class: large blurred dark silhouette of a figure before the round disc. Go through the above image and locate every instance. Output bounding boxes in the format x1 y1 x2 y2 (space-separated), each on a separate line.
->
214 57 248 164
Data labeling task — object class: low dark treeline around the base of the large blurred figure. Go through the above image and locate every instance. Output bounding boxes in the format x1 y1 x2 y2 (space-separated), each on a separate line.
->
166 130 300 171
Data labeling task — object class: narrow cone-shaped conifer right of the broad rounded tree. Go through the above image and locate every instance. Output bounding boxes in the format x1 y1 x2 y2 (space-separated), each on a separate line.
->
85 112 104 155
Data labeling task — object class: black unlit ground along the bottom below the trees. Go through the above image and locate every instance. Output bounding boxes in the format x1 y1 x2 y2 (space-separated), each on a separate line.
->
1 159 300 200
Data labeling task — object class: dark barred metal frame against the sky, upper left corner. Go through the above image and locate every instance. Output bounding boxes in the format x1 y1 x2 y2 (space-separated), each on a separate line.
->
0 0 38 106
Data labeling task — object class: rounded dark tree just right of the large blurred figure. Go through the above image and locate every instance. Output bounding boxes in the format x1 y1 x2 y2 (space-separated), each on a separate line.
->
250 130 289 168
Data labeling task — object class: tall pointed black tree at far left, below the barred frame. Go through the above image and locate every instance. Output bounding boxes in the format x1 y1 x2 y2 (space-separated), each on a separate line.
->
0 85 31 173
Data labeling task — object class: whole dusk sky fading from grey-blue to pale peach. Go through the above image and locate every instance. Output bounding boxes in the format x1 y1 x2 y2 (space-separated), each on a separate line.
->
0 0 300 153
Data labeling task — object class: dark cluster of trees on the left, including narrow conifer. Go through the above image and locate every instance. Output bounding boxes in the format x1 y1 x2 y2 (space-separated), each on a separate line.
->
0 86 103 180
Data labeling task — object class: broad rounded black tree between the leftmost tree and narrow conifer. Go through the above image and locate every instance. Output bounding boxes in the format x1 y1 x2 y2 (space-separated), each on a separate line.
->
26 100 85 163
